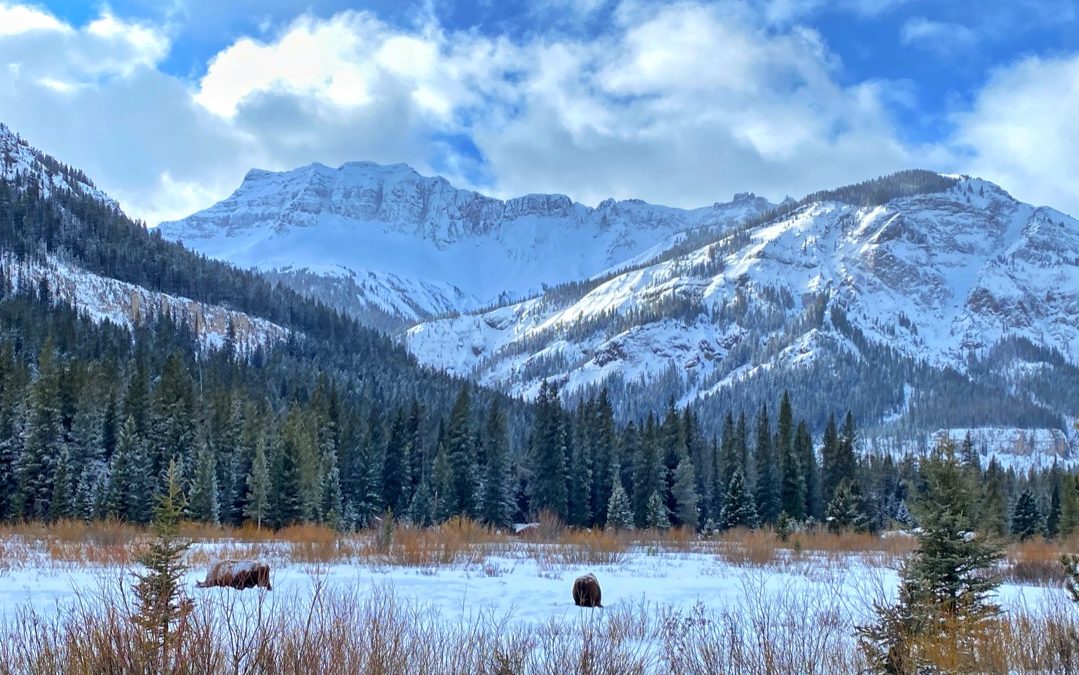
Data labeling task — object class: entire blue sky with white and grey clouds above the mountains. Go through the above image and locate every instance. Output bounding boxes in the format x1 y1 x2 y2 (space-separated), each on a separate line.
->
0 0 1079 225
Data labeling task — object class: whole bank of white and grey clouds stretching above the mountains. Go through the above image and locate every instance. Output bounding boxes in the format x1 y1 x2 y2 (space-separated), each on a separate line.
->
0 0 1079 228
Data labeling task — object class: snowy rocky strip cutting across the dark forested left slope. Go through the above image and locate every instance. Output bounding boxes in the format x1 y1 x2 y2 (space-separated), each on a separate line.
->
0 253 288 354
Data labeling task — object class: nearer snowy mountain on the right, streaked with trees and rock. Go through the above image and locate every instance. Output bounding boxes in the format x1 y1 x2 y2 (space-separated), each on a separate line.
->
407 171 1079 448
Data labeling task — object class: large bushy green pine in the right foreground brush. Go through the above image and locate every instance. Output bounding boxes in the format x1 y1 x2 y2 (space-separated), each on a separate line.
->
858 444 1001 673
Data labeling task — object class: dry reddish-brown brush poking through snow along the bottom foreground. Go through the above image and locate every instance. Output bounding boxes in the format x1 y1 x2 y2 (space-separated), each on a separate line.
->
0 575 1079 675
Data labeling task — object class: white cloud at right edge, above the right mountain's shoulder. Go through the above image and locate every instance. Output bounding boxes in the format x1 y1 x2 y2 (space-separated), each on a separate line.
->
955 54 1079 216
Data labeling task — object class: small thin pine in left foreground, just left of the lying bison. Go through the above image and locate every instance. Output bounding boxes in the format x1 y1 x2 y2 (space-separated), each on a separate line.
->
133 460 191 673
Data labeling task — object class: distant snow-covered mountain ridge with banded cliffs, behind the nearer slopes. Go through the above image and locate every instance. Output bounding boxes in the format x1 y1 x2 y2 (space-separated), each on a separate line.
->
160 162 771 325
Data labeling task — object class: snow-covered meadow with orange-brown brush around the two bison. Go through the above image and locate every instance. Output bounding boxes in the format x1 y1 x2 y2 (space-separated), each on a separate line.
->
0 521 1079 673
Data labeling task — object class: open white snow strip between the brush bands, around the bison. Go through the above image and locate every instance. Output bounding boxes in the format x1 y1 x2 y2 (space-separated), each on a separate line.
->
0 539 1063 624
